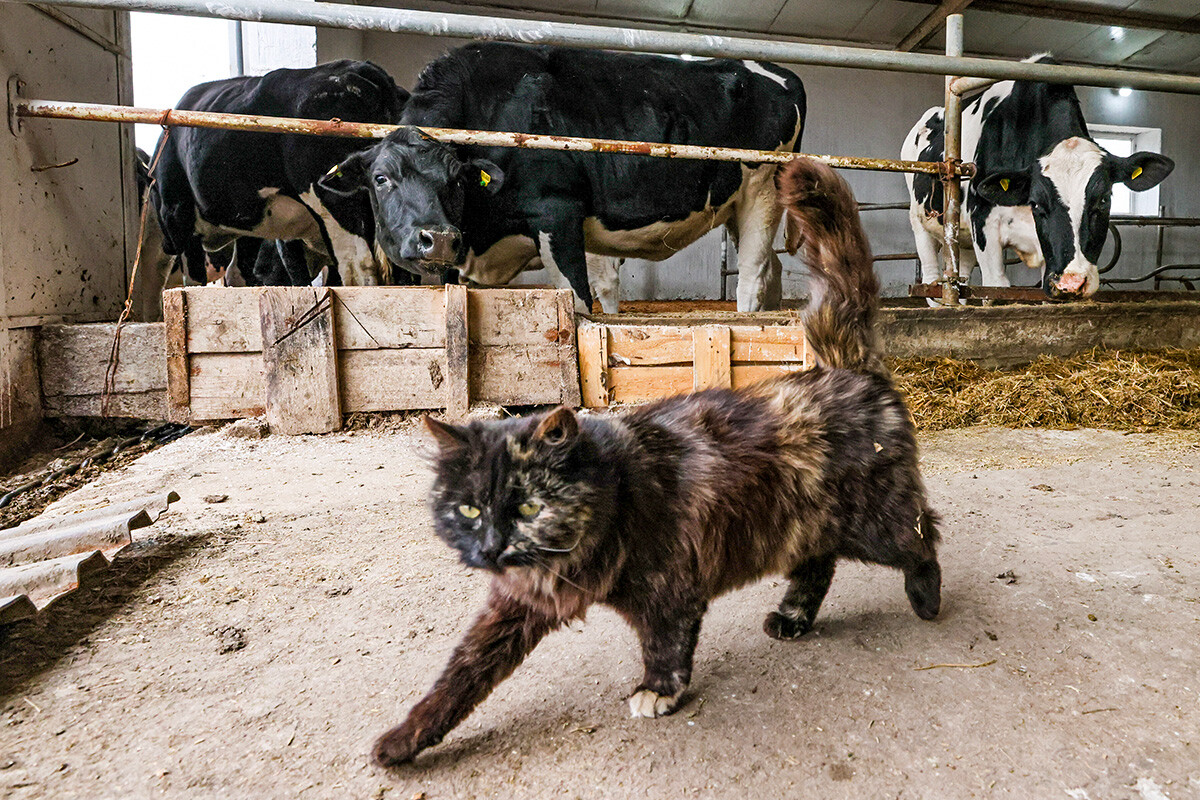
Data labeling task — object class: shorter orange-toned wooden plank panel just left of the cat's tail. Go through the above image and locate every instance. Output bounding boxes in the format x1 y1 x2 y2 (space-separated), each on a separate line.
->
578 313 809 408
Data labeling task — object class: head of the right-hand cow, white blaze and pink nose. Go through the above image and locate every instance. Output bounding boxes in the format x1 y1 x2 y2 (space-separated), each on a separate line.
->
974 137 1175 297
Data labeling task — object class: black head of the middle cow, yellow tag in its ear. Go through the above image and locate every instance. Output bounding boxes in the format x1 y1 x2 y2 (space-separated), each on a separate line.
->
318 127 504 277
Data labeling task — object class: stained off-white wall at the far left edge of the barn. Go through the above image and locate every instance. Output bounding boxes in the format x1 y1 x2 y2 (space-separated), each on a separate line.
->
0 4 137 461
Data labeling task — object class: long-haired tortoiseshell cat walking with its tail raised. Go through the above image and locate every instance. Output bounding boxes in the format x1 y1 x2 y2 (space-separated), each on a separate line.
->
374 160 941 765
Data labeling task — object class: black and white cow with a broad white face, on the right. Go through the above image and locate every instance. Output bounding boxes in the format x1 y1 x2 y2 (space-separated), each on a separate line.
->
901 56 1175 299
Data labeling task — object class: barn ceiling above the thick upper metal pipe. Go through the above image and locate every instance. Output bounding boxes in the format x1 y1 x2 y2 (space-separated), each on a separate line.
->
398 0 1200 74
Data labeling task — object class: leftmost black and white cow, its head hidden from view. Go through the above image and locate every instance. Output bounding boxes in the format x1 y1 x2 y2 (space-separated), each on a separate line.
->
152 61 408 284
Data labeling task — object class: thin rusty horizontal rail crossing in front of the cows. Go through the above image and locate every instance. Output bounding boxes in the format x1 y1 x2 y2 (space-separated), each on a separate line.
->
14 100 974 175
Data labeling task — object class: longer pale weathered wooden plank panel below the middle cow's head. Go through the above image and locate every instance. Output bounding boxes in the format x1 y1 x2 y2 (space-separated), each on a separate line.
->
163 285 580 433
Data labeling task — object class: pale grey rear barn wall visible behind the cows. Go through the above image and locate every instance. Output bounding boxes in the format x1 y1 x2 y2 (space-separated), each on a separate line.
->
317 23 1200 300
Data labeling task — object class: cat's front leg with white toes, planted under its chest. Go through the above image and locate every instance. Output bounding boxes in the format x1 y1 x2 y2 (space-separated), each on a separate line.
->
629 601 708 718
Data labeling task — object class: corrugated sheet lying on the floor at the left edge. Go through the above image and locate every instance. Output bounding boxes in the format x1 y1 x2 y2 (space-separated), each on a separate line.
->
0 492 179 624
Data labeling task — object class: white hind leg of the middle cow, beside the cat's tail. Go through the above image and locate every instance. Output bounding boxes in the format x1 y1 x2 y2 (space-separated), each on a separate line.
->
734 164 782 311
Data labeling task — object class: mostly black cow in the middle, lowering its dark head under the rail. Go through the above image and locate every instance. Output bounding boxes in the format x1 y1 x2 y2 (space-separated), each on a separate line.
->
322 43 805 312
